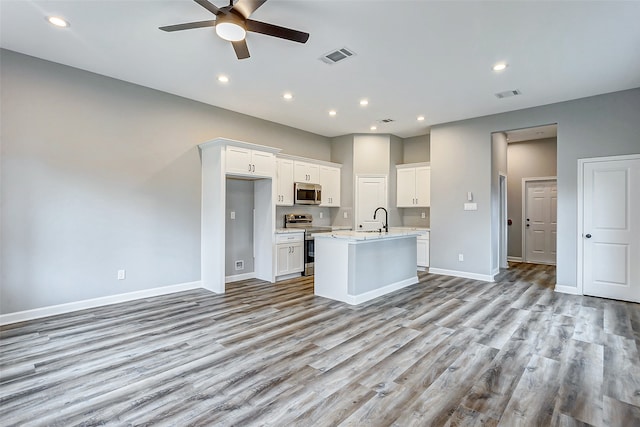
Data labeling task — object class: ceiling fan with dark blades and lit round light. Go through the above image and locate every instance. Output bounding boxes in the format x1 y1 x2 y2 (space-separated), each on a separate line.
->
160 0 309 59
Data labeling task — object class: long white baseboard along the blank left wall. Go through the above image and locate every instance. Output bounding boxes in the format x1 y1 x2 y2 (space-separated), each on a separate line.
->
0 280 202 325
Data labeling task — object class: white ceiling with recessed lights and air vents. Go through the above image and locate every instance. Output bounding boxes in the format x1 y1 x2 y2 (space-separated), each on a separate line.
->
0 0 640 137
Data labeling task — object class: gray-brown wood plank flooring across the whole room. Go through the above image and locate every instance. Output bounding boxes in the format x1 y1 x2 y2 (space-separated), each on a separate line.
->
0 264 640 426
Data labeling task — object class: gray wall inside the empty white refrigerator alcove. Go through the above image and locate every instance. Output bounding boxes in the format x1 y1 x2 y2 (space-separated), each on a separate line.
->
224 178 255 276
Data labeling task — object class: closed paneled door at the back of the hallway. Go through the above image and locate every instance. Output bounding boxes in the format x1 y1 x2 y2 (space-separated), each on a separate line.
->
524 179 558 265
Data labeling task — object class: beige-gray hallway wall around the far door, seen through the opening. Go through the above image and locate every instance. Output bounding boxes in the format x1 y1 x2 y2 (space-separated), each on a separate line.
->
507 138 557 258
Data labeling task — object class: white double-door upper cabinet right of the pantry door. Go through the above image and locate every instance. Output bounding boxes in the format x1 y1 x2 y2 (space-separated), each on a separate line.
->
396 165 431 208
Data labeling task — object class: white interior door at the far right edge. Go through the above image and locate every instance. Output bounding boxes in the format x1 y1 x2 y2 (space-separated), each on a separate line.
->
580 156 640 302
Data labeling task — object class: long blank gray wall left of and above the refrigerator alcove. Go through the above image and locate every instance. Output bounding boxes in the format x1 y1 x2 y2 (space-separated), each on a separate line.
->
0 50 331 314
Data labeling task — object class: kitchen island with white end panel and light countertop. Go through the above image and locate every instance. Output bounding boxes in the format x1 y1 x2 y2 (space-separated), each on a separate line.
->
314 228 419 305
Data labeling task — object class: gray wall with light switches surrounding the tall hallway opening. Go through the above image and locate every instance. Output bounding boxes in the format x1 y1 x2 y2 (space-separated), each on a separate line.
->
430 89 640 287
